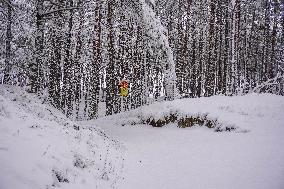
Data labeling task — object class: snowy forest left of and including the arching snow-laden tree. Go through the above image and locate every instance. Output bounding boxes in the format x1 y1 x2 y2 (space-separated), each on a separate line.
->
1 0 175 119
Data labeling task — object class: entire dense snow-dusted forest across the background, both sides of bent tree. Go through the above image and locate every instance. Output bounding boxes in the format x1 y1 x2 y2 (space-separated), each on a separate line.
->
0 0 284 119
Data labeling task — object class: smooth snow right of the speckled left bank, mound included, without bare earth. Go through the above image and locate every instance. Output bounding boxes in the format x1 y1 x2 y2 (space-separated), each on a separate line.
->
84 94 284 189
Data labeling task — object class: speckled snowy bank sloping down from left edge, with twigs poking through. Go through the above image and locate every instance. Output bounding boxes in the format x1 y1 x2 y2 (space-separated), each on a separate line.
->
0 85 124 189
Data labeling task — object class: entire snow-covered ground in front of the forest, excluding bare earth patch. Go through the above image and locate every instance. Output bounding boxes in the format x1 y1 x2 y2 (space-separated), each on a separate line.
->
0 86 284 189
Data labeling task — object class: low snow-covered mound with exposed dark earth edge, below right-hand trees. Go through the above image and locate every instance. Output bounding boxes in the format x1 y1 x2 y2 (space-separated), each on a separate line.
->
97 93 284 133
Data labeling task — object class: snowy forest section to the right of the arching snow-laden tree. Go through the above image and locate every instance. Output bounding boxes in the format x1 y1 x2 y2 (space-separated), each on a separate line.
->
155 0 284 97
